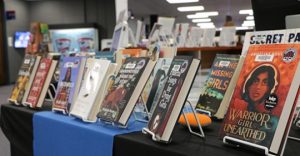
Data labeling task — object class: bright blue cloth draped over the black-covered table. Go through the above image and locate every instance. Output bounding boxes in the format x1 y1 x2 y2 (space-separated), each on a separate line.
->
33 112 145 156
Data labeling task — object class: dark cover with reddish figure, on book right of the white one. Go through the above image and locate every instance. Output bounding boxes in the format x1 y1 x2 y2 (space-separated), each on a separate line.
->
98 57 151 122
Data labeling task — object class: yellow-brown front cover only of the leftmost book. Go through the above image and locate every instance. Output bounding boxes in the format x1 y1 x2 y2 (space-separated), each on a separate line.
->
9 54 36 104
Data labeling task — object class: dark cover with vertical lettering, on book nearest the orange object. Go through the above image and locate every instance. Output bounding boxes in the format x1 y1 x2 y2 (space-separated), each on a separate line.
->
148 56 196 138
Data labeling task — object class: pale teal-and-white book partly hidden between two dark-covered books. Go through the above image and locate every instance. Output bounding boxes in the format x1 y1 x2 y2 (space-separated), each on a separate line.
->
137 58 172 116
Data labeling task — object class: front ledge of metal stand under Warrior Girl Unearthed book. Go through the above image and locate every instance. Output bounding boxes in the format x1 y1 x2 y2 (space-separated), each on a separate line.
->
223 136 276 156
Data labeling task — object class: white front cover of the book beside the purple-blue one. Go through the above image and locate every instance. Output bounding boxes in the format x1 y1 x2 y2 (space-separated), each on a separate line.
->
70 59 110 119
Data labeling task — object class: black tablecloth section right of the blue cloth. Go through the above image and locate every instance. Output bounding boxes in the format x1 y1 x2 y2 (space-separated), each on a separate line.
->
114 122 300 156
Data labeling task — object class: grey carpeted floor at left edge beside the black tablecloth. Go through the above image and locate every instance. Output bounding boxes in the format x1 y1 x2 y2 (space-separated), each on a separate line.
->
0 85 13 156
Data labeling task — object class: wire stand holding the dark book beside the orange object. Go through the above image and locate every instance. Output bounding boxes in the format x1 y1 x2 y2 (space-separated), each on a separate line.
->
142 101 205 143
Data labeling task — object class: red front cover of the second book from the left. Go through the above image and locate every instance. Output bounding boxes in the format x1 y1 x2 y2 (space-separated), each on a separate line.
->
26 58 52 107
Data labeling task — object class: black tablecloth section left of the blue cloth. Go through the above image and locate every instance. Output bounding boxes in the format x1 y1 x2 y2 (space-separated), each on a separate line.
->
0 104 50 156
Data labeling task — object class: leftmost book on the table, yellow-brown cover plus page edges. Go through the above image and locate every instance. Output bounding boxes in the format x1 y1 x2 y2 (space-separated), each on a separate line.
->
8 54 41 105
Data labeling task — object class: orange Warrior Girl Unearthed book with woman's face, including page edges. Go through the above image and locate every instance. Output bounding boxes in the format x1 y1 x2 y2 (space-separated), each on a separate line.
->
220 44 300 155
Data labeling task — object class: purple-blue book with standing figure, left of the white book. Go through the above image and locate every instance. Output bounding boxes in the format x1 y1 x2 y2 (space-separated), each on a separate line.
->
52 57 86 114
